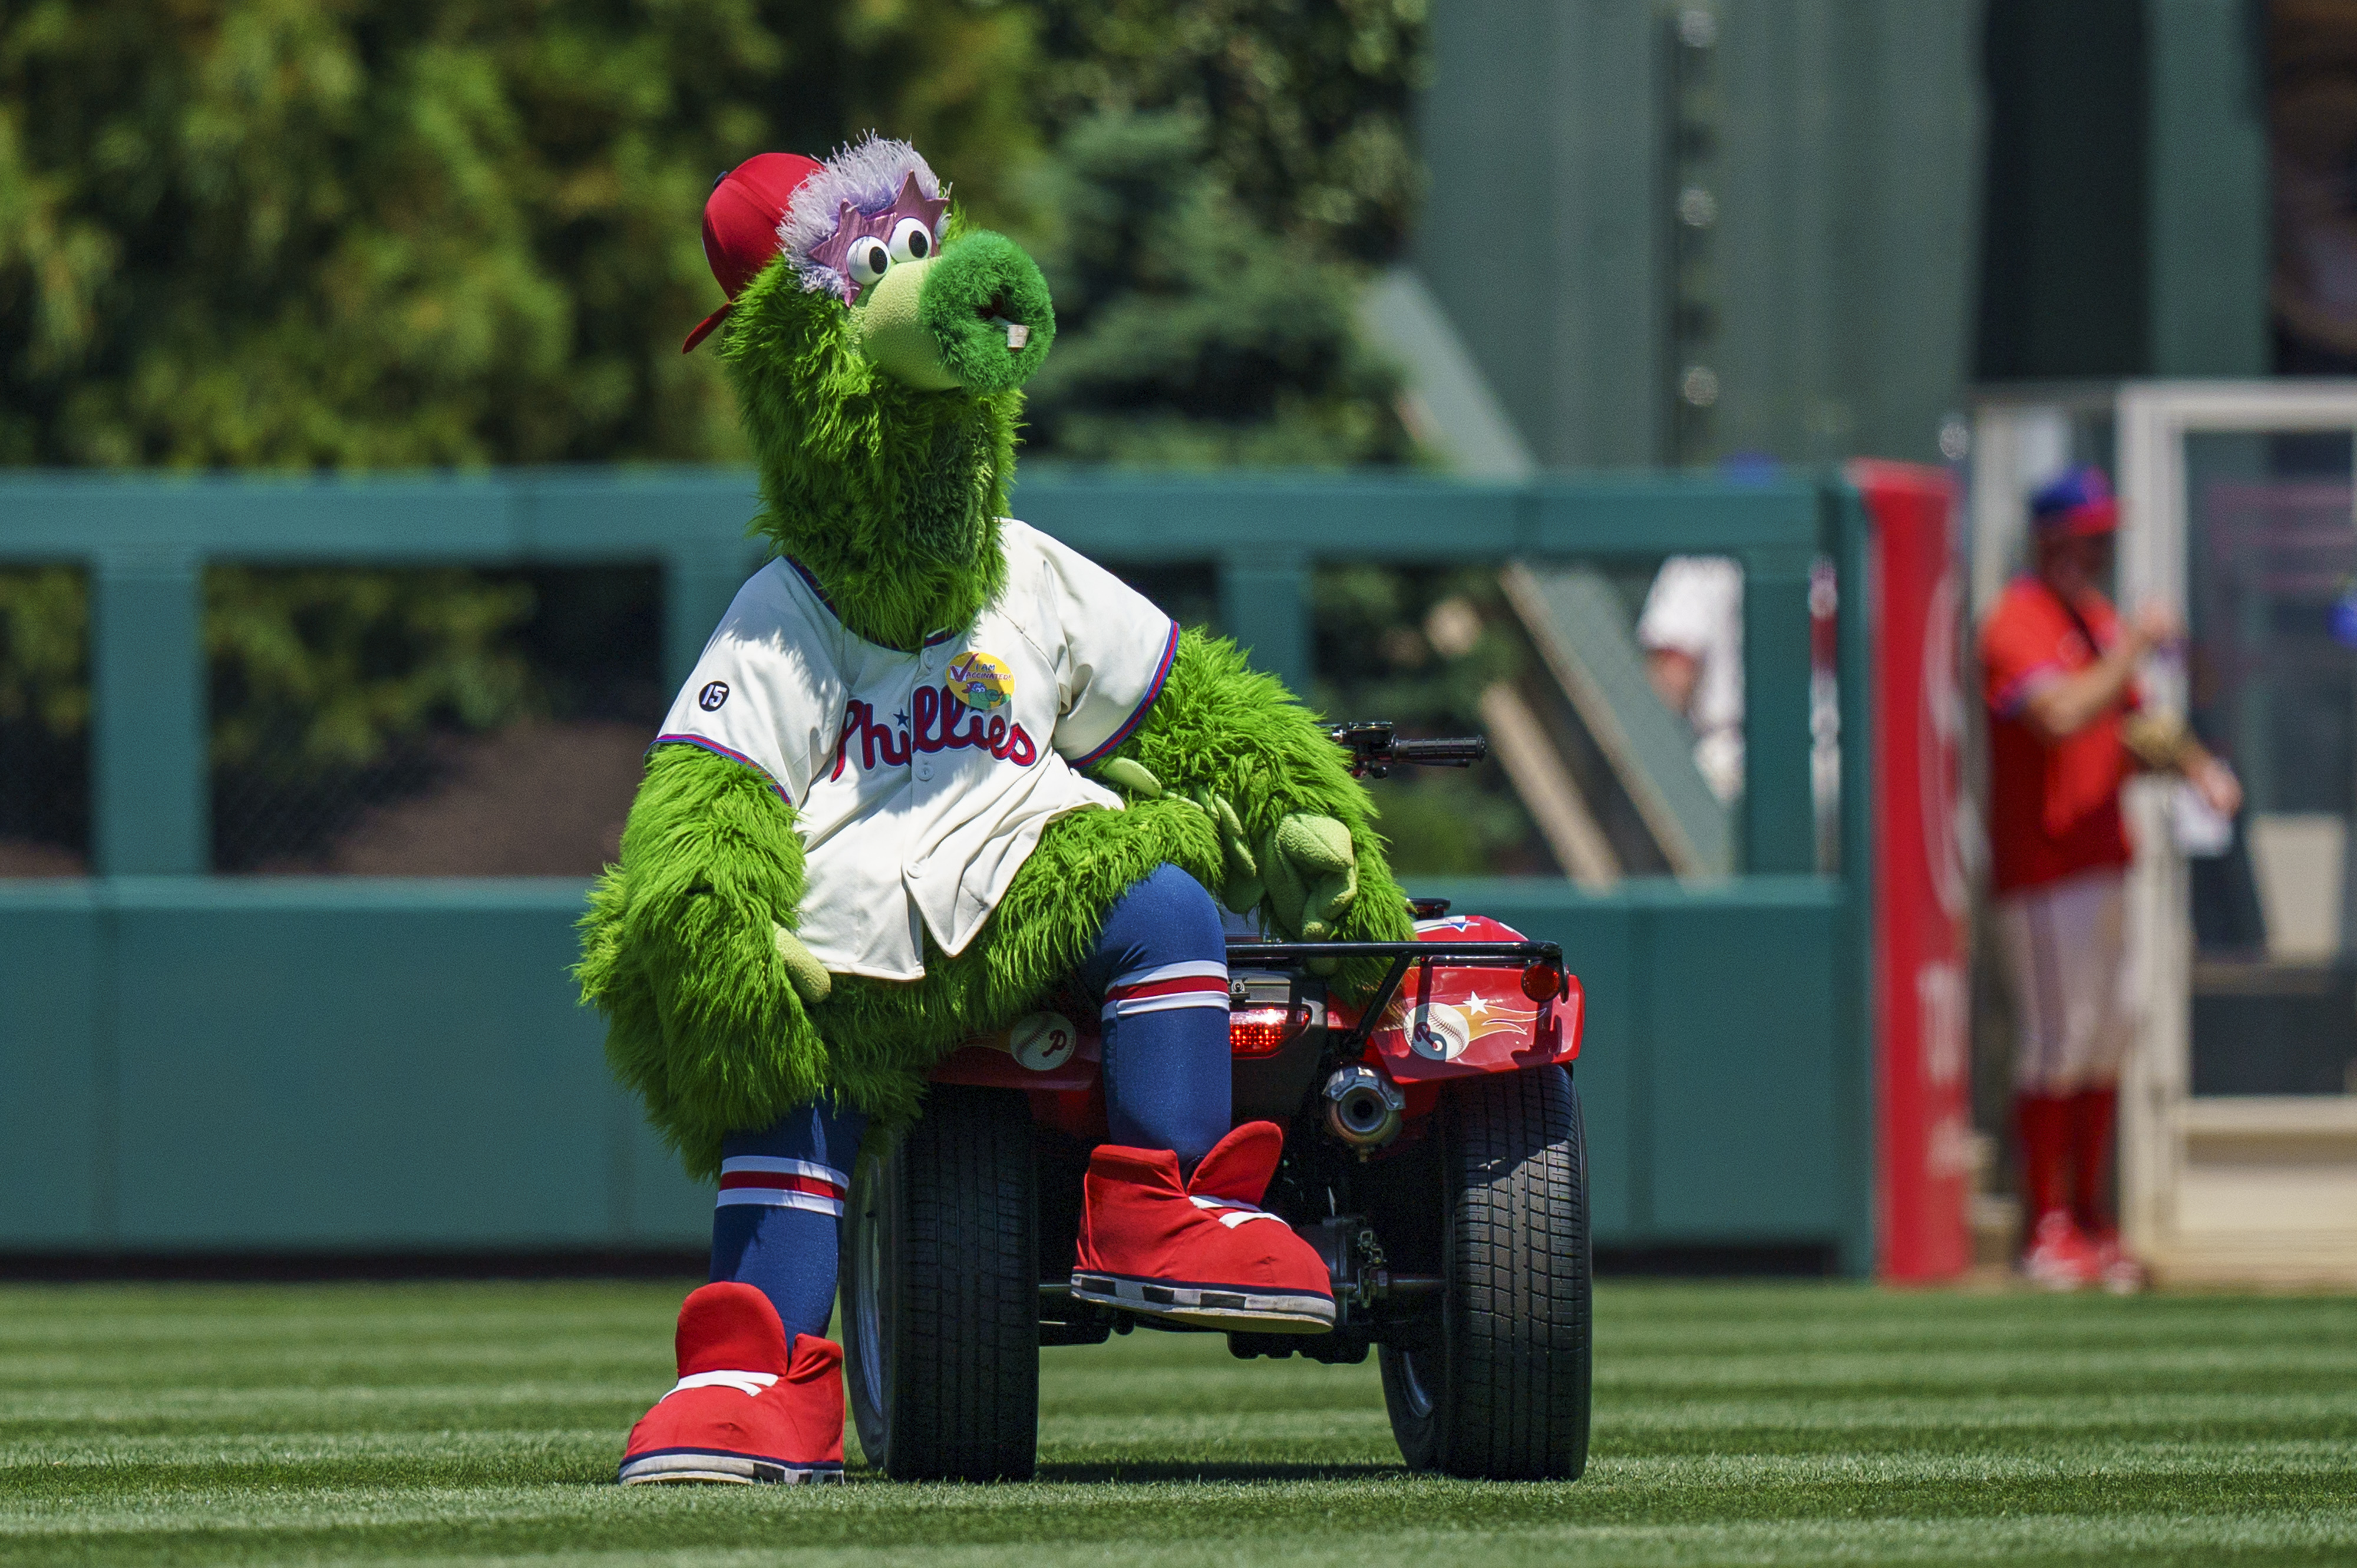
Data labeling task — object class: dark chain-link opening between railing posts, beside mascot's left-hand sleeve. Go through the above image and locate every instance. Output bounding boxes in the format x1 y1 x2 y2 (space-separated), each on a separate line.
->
205 566 667 877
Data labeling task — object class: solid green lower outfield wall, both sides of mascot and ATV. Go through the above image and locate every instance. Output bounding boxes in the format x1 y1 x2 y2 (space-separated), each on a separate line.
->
0 877 1864 1264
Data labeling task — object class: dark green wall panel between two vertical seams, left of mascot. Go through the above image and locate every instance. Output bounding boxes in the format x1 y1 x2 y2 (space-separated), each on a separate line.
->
118 908 610 1247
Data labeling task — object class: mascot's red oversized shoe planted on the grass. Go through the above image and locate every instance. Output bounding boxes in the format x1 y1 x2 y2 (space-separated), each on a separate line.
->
620 1280 844 1486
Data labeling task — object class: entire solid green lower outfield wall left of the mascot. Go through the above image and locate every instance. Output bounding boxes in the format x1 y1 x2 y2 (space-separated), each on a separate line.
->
0 877 709 1250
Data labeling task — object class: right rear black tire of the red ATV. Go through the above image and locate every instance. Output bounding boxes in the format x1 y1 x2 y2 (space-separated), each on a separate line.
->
1381 1068 1593 1481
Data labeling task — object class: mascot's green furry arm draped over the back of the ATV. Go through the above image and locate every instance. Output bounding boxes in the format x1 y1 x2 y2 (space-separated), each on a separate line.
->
1120 632 1414 988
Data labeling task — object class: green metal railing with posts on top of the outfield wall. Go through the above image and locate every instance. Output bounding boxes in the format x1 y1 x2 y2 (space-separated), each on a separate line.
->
0 469 1855 875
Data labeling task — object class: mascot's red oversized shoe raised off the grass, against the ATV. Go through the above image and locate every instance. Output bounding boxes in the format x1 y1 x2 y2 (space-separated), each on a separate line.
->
1072 1123 1334 1335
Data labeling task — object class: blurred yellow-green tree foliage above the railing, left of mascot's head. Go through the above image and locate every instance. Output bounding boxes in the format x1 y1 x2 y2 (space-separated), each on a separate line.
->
0 0 1032 467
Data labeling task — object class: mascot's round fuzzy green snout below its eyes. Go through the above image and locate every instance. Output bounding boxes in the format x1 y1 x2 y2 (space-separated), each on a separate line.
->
851 229 1056 394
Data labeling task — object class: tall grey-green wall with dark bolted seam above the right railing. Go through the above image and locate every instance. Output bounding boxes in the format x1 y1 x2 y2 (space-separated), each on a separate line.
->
1412 0 1989 467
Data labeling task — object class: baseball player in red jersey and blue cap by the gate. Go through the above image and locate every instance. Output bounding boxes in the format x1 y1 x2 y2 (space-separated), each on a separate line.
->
1980 467 2242 1290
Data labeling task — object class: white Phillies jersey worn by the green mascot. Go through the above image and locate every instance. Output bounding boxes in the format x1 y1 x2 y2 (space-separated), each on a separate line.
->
655 519 1178 981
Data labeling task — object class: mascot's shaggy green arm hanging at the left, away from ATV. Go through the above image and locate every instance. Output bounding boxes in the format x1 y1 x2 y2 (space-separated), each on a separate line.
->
575 745 827 1177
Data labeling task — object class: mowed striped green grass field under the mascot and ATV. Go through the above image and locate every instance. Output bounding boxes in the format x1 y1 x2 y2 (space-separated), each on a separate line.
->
0 1280 2357 1568
